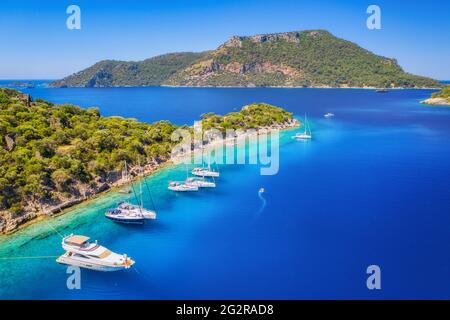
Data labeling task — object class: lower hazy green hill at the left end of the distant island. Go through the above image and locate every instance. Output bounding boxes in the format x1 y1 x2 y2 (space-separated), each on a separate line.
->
50 52 208 87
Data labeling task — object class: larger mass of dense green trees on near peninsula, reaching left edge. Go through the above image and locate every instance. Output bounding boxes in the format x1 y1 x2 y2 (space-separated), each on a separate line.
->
0 89 176 212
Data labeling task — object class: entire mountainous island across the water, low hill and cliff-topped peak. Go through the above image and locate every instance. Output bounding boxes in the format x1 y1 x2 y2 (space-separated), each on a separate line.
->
51 30 439 88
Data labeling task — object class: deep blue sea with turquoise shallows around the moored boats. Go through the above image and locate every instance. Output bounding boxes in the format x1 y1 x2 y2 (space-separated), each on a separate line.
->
0 81 450 299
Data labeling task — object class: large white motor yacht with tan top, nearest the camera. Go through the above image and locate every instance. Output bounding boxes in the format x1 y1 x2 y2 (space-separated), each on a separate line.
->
56 234 134 271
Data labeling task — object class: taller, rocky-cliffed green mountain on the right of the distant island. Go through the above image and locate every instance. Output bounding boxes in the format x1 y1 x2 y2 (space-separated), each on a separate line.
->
169 30 437 87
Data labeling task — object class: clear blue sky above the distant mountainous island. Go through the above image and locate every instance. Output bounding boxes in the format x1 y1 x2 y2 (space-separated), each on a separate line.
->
0 0 450 80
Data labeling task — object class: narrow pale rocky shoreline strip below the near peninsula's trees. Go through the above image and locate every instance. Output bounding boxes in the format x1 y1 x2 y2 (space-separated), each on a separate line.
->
0 118 300 238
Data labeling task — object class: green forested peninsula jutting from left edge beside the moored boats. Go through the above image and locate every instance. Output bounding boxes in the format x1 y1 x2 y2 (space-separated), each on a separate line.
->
0 88 296 233
